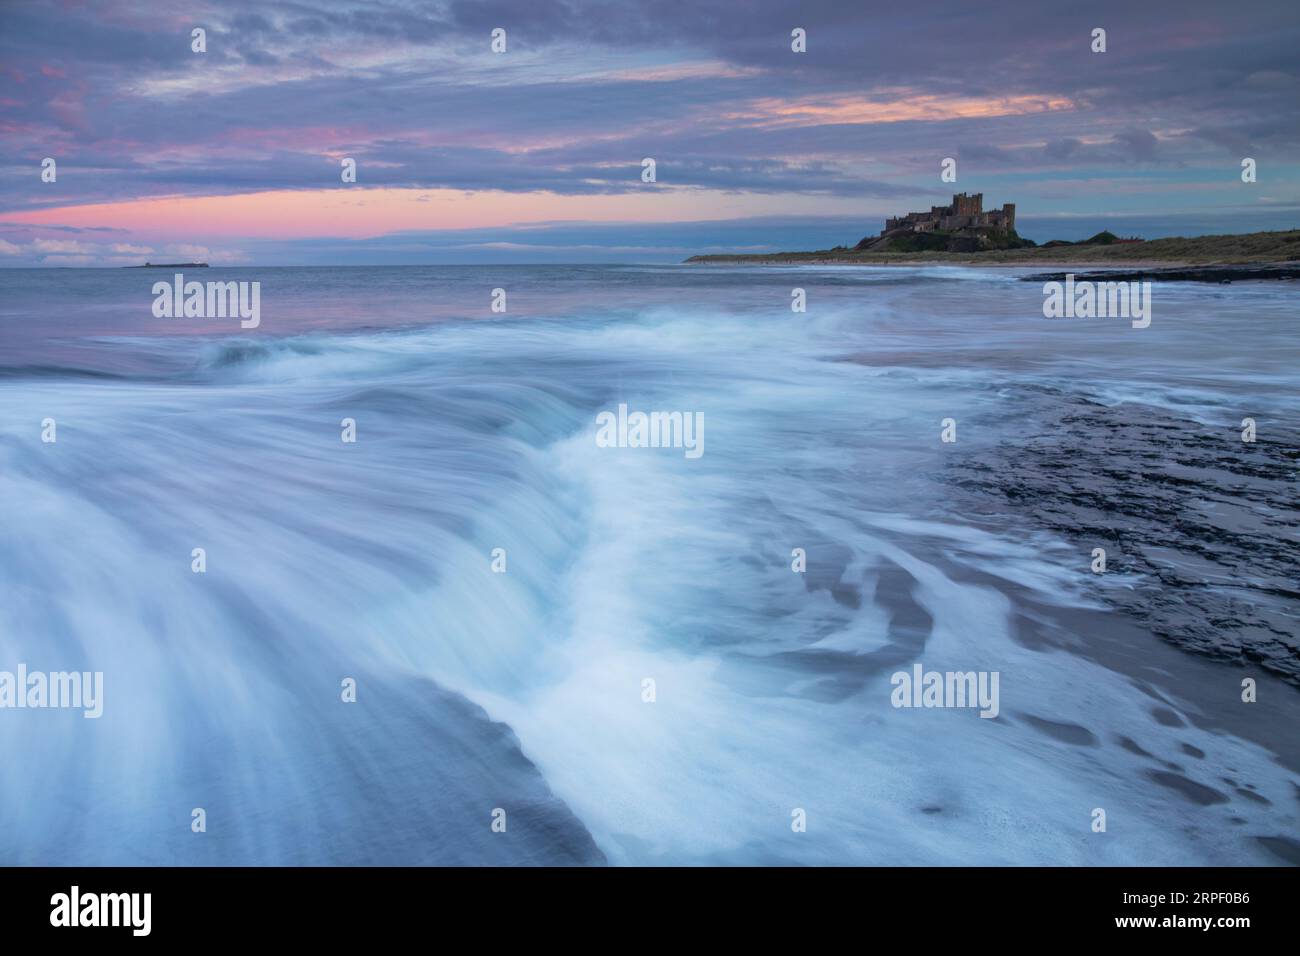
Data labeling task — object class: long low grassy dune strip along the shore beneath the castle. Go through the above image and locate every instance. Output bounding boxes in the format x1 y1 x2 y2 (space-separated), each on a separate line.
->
686 229 1300 265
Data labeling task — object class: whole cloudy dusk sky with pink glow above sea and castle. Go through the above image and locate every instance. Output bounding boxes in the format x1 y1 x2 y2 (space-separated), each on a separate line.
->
0 0 1300 267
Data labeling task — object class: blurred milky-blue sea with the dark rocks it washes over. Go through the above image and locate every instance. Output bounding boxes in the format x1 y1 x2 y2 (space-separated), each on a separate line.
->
0 265 1300 866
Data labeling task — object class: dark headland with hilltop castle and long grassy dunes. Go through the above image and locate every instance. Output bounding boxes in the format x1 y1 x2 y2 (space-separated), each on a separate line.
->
686 193 1300 272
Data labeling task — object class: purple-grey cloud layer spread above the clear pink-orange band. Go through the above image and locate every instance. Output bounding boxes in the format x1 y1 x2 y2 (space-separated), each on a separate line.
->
0 0 1300 256
